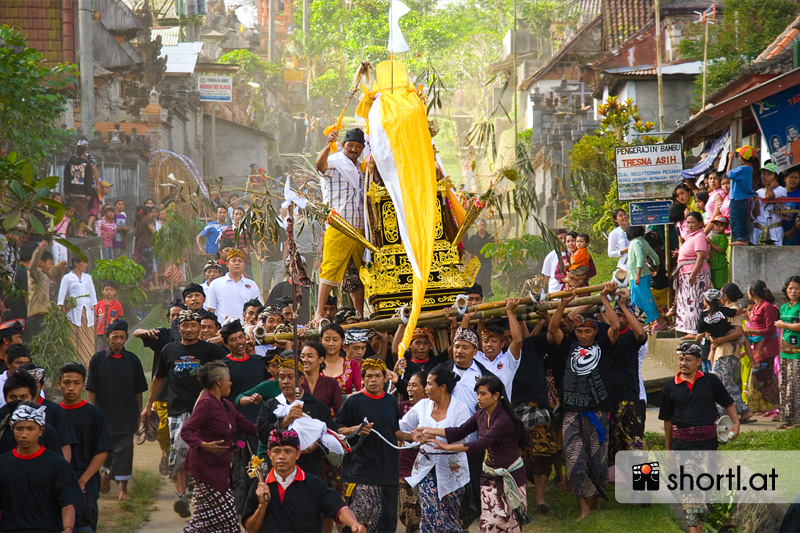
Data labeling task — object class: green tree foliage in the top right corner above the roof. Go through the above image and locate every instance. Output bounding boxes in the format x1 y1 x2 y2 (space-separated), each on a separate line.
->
678 0 800 102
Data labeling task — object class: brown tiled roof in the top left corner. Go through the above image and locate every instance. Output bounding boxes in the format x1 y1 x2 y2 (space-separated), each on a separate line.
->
0 0 76 63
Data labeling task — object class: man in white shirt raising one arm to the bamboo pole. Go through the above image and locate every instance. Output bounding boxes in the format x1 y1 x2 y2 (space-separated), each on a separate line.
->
475 298 522 398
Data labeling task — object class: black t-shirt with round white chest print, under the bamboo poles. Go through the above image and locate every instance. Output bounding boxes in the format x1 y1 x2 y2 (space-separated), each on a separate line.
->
558 329 614 411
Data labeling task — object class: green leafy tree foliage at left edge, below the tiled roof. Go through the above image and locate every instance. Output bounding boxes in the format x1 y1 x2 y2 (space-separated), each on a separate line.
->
0 26 77 163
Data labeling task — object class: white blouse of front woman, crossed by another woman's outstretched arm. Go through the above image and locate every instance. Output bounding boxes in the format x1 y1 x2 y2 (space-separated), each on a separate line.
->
400 398 471 500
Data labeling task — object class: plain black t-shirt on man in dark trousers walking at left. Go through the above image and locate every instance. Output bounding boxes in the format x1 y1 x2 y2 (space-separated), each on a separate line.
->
86 349 147 435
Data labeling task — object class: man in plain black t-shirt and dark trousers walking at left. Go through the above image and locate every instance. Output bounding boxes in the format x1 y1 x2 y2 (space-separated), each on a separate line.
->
86 319 147 500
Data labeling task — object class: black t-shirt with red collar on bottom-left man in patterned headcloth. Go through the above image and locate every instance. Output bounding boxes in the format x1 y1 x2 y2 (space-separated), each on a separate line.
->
0 448 83 531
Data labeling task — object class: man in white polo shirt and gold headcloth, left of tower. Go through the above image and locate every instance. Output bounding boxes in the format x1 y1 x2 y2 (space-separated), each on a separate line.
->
206 248 261 324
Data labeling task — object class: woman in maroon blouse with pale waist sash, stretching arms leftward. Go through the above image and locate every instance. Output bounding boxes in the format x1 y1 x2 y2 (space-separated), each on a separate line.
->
424 376 531 533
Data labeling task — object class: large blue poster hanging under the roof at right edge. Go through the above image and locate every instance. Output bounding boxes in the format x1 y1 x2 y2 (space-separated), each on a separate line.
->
750 85 800 172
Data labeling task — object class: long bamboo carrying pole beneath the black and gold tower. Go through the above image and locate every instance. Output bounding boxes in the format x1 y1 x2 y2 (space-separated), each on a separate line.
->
253 285 602 345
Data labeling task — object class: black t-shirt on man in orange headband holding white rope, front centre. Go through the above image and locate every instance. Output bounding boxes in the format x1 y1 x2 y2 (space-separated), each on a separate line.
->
336 392 400 485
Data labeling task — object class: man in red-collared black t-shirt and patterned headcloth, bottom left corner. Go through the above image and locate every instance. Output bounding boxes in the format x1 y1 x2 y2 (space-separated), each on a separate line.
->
0 402 81 532
